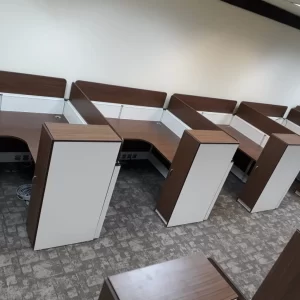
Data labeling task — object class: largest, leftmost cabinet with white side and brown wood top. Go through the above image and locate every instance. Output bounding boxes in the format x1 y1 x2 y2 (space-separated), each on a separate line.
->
27 123 121 250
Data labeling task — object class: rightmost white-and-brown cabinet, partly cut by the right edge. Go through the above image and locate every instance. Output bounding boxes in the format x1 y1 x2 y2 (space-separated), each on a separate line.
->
239 134 300 212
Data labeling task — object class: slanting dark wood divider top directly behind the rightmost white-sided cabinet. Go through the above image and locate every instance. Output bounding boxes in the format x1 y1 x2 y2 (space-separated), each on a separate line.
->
236 102 294 135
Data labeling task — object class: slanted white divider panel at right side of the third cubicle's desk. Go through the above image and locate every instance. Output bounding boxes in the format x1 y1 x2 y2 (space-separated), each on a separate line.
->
230 116 266 145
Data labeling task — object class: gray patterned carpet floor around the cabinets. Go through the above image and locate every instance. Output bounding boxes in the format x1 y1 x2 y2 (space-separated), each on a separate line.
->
0 163 300 300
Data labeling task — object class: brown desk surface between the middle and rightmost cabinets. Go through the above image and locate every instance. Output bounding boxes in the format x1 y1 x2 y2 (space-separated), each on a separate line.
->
218 125 263 161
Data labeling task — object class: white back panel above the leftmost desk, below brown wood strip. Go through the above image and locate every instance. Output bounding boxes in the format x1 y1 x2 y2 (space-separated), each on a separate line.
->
1 94 65 115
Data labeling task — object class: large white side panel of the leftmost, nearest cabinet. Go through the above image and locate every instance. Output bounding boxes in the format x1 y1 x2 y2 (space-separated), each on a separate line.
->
34 142 121 250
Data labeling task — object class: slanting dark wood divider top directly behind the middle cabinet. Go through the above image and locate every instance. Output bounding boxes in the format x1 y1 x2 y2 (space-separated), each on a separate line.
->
168 96 220 131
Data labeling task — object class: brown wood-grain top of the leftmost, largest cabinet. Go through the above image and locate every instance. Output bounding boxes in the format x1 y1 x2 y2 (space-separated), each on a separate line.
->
45 123 121 142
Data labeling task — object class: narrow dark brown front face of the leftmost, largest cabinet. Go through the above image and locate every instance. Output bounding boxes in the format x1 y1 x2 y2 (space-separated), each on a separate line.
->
27 126 53 247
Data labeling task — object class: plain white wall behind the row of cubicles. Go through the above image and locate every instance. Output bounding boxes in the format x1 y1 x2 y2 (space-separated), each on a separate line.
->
0 0 300 106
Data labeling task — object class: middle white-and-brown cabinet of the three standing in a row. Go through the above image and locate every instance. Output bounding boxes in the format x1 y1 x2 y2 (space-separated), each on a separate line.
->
157 130 238 227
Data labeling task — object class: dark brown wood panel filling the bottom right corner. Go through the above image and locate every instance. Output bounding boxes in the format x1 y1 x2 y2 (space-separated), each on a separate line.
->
252 230 300 300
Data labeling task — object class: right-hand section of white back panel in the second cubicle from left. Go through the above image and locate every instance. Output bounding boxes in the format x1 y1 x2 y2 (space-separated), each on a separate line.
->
120 105 164 122
